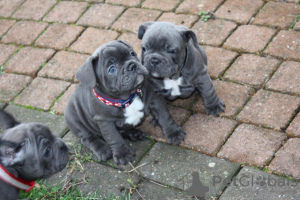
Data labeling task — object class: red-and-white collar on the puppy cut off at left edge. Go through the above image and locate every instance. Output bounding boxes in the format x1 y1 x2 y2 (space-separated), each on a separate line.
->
0 164 34 192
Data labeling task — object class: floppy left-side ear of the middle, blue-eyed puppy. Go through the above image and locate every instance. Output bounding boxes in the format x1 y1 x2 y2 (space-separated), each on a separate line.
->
75 54 99 87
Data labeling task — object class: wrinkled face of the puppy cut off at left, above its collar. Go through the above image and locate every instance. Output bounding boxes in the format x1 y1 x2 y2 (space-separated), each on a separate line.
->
2 123 69 181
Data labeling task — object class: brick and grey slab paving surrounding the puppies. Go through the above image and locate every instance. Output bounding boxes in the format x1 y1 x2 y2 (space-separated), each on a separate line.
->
0 0 300 200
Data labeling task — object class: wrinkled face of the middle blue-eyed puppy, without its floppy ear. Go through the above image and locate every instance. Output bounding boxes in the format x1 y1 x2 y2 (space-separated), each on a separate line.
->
93 41 148 97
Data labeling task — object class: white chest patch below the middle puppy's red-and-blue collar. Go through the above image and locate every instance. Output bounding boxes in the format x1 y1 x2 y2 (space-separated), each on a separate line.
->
124 97 144 126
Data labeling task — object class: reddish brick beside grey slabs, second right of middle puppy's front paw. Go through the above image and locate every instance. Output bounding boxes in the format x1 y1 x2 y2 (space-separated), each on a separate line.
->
218 124 286 167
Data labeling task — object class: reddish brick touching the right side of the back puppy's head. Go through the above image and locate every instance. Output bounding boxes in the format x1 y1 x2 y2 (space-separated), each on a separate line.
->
192 19 236 46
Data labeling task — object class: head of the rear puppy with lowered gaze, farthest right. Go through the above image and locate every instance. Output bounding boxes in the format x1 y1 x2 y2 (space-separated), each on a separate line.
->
138 22 198 78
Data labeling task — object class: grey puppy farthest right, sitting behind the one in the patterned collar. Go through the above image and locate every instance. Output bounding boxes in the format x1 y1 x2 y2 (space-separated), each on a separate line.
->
138 22 225 116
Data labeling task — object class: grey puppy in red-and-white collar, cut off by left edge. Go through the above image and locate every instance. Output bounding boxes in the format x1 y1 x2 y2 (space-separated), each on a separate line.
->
0 109 69 200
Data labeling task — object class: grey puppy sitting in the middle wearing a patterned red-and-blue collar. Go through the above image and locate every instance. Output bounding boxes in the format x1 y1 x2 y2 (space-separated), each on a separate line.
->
65 40 185 164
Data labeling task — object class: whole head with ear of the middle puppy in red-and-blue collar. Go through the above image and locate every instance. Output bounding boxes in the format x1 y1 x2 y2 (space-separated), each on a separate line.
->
76 40 148 98
